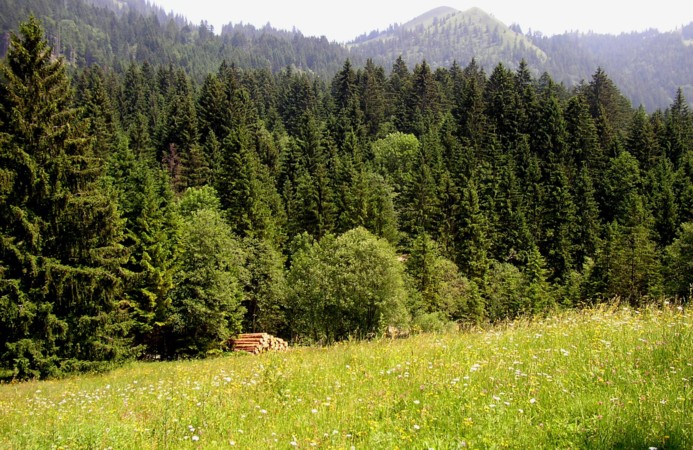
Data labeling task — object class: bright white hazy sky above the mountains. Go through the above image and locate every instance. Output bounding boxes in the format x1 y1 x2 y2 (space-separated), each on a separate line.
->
152 0 693 42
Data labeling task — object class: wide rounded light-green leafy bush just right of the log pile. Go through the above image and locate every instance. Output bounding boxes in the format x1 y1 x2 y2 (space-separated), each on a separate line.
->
288 228 408 342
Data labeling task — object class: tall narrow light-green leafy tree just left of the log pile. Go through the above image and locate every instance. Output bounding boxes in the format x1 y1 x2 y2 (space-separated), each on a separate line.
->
164 187 245 357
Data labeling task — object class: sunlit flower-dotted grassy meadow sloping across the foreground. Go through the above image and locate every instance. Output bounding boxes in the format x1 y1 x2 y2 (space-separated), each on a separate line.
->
0 307 693 449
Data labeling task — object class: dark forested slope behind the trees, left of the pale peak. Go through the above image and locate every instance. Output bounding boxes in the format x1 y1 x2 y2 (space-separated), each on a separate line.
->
0 0 348 78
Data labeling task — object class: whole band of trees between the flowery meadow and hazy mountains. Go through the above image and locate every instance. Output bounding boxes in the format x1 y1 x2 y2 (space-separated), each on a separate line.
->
0 18 693 378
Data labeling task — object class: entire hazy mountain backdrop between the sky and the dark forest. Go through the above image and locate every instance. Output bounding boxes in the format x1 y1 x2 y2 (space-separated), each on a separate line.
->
0 0 693 112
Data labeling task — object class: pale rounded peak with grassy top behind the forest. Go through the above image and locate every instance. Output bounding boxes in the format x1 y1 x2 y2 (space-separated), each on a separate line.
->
349 7 547 69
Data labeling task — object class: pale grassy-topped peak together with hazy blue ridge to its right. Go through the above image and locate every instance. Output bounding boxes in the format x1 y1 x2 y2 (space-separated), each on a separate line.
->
349 8 693 111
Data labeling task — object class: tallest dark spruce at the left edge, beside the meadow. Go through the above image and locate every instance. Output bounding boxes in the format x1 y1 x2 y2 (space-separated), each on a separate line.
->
0 17 132 378
